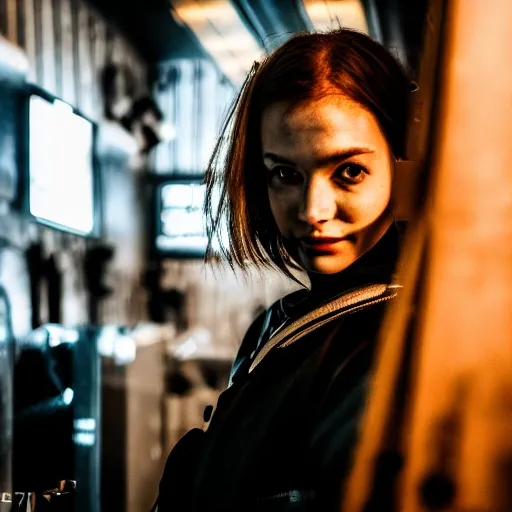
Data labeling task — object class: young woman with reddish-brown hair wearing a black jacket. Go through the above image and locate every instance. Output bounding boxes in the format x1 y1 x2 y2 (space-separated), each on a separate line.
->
154 29 409 512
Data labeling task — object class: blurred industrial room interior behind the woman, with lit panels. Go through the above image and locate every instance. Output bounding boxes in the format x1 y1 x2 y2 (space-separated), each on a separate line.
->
0 0 429 512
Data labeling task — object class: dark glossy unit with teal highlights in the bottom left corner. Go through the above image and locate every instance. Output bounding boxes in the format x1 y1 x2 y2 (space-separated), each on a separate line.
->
13 324 100 512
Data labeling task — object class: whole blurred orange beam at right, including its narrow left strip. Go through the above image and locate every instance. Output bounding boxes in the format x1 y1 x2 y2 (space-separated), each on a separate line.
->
344 0 512 512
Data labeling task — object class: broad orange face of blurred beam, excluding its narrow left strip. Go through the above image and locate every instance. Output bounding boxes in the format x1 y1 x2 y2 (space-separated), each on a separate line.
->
400 0 512 512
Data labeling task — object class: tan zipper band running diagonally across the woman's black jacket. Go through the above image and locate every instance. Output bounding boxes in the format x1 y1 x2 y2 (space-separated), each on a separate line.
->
249 284 401 373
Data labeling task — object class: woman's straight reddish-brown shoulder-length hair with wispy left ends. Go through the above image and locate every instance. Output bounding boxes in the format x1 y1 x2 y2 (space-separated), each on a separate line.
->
205 29 409 279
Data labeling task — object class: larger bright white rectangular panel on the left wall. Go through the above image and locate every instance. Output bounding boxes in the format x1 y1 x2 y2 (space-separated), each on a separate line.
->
28 94 95 235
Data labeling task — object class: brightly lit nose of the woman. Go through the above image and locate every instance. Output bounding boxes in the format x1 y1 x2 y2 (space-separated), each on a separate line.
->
299 177 337 225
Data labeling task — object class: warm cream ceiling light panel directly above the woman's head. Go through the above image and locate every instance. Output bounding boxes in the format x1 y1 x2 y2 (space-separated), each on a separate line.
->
302 0 368 34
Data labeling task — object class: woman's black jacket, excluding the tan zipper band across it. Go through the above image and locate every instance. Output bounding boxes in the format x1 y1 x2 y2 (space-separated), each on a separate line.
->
158 227 399 512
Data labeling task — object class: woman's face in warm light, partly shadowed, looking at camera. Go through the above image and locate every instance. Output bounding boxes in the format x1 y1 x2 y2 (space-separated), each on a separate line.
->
261 95 392 274
